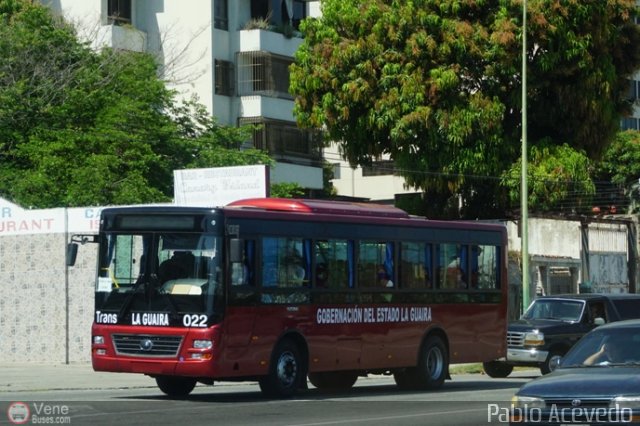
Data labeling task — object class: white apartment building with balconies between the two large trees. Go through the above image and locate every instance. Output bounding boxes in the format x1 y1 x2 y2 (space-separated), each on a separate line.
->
43 0 322 194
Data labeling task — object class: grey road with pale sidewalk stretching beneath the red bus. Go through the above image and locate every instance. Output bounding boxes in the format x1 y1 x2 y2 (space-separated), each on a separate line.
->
0 365 538 426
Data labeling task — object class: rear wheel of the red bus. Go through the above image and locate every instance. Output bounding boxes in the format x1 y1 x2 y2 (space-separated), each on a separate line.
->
416 336 449 390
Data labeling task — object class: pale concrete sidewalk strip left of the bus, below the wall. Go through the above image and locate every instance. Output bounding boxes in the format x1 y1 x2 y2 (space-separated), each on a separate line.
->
0 363 156 397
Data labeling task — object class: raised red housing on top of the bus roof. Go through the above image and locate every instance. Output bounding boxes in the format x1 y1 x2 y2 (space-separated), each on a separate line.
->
226 198 410 219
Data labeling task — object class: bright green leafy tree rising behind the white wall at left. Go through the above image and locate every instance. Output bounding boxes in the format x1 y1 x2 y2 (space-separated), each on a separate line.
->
0 0 271 208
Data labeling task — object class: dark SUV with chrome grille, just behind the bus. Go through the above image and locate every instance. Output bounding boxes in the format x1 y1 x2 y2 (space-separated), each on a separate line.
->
484 293 640 377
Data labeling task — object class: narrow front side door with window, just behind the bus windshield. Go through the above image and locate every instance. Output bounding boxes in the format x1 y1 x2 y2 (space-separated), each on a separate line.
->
225 240 258 347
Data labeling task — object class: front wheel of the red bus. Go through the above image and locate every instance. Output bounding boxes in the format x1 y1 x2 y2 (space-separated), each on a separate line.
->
259 339 306 398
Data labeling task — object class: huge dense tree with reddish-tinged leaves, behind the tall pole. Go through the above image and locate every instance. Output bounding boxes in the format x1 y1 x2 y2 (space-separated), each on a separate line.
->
291 0 640 217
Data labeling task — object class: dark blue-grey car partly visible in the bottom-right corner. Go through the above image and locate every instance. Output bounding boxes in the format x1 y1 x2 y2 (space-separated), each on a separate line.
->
511 320 640 425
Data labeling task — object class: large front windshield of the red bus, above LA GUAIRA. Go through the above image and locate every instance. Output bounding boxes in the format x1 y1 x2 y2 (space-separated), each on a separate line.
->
96 232 223 325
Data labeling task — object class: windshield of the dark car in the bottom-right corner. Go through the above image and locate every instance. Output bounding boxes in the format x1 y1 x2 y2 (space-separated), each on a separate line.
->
560 327 640 368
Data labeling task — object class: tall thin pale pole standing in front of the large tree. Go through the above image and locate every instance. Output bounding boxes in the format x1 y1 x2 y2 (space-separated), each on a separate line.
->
520 0 529 312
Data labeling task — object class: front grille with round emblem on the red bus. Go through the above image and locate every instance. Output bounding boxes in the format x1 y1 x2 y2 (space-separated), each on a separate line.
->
112 334 182 357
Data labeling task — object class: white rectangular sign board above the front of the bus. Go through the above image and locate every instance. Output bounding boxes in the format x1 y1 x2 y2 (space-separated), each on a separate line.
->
173 165 269 207
